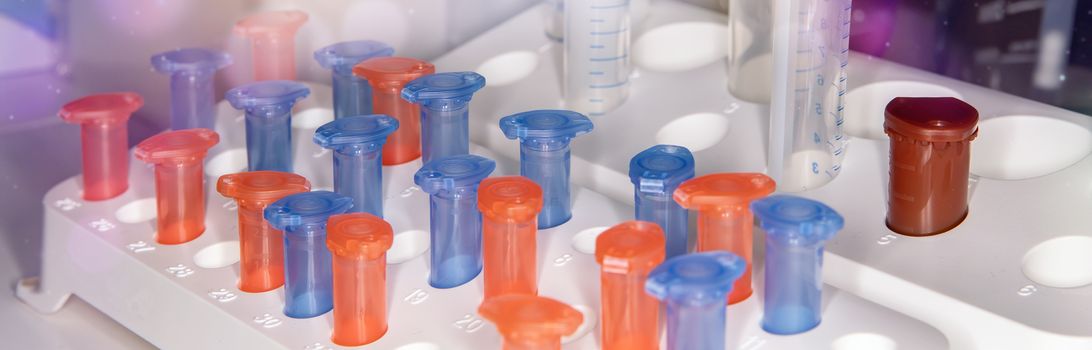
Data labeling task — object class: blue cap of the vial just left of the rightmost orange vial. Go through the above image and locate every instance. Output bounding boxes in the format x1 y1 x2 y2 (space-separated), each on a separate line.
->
629 145 693 195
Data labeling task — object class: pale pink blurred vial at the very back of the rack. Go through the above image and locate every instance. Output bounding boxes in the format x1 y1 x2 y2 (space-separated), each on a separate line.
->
235 11 307 81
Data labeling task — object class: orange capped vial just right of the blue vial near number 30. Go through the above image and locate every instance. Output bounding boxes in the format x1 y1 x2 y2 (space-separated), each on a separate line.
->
327 213 394 347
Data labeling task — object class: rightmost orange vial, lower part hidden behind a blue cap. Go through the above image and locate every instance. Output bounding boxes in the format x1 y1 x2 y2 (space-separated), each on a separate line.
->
675 172 774 304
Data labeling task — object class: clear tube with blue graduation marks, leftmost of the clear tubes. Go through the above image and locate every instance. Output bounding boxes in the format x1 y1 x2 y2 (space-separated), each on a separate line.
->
561 0 630 116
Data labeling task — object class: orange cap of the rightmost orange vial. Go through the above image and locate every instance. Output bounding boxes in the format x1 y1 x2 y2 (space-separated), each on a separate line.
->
674 172 776 209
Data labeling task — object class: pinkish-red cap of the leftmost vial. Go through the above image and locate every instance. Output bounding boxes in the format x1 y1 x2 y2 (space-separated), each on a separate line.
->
59 93 144 124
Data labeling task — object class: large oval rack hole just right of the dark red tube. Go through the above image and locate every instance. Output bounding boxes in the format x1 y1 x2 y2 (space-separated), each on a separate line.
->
971 116 1092 180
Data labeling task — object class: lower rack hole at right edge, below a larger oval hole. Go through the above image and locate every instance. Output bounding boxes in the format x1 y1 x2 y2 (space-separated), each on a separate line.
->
1023 236 1092 288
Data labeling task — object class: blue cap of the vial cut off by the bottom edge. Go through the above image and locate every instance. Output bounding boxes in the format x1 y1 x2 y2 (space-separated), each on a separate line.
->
644 251 747 305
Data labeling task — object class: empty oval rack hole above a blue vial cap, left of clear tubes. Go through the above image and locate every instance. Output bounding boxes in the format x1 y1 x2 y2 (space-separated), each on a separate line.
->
656 113 729 152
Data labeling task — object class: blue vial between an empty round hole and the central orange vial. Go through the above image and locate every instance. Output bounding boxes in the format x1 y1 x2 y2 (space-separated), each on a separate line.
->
413 155 497 288
